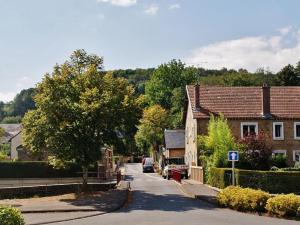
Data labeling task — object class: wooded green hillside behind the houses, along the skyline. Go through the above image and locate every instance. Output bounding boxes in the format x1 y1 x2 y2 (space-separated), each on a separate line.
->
0 60 300 127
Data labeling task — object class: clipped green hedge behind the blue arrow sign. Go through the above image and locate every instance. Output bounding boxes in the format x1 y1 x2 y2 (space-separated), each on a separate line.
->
209 168 300 194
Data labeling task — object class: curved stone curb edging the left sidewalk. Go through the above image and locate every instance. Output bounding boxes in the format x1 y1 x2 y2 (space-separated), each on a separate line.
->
27 182 130 225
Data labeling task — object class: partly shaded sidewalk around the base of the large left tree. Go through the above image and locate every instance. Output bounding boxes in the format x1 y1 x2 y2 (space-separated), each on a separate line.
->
0 182 128 213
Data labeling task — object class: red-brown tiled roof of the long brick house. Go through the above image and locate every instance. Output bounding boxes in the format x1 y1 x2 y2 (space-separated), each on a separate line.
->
187 85 300 119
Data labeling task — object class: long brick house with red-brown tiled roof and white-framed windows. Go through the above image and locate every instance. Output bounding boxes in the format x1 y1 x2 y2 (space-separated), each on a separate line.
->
185 85 300 166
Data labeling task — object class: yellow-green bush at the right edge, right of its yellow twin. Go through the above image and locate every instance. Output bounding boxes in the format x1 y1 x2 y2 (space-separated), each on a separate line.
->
266 194 300 217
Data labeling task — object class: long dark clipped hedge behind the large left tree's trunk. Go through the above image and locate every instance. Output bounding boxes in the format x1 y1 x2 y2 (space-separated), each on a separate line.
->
0 161 96 178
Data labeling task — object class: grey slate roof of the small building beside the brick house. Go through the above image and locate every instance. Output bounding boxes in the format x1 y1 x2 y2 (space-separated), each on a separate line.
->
165 130 185 149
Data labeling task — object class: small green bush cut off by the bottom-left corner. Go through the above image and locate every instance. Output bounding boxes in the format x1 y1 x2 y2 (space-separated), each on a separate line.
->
0 206 25 225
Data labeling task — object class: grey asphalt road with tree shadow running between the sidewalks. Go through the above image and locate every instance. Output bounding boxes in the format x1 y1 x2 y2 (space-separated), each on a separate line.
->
33 164 300 225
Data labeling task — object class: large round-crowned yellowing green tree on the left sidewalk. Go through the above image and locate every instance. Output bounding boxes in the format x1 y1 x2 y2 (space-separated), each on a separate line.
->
23 50 138 188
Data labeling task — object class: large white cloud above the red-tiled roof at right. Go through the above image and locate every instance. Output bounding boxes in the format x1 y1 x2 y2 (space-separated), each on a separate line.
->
184 27 300 72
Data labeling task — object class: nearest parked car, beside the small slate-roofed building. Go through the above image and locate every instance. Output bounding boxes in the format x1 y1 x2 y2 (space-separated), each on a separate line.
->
162 157 189 180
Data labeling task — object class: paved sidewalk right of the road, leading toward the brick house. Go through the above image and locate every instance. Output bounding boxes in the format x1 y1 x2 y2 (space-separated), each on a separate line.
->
180 180 219 205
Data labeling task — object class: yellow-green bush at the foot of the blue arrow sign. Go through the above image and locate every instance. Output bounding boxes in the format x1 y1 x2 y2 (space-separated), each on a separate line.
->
217 186 270 212
